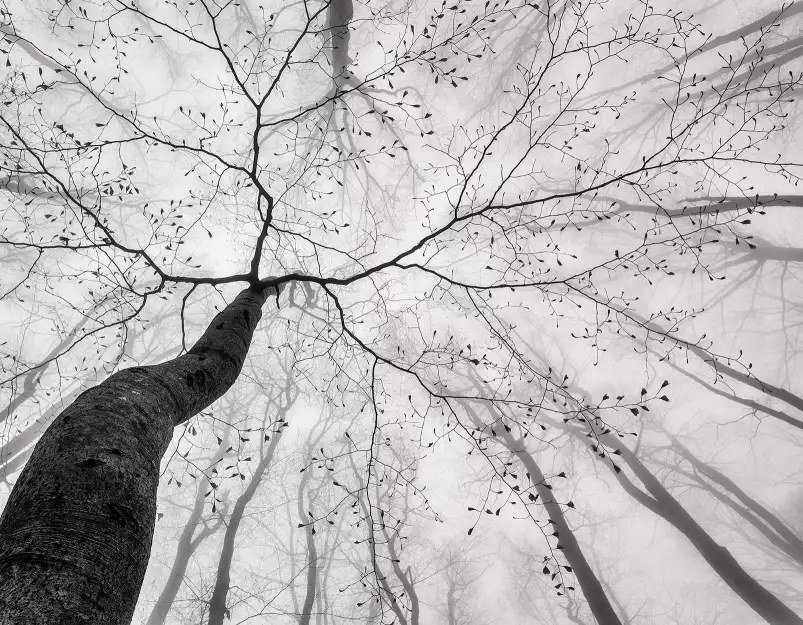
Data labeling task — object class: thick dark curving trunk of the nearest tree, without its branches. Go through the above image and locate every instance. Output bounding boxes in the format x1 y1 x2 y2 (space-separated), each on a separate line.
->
0 289 274 625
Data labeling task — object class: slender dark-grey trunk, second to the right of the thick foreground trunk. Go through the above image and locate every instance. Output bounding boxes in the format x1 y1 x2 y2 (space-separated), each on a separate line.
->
209 416 284 625
